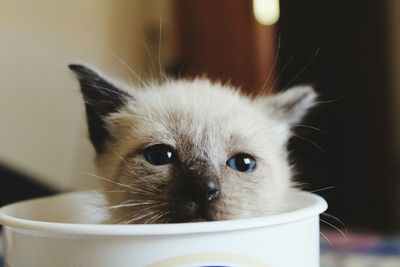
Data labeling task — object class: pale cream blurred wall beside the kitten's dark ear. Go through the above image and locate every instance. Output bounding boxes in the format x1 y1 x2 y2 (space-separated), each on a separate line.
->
0 0 175 189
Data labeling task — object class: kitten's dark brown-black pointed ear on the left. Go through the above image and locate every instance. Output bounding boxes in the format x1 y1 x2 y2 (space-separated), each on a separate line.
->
68 64 133 153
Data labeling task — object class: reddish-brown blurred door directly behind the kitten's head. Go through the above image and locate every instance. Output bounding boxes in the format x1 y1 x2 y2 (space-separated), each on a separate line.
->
175 0 276 93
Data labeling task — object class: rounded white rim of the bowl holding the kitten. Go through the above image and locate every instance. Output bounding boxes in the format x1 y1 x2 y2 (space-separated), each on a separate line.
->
0 191 328 236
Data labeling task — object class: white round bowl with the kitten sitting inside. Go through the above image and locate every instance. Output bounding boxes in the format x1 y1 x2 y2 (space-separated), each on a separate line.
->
0 192 327 267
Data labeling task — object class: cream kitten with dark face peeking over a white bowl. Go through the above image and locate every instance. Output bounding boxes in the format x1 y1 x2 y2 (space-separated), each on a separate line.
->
69 65 316 223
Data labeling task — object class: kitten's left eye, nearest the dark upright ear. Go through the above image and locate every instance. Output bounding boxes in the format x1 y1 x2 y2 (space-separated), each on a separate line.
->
143 144 176 165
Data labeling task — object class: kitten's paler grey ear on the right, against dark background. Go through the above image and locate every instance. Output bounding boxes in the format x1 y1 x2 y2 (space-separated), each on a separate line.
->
263 86 317 126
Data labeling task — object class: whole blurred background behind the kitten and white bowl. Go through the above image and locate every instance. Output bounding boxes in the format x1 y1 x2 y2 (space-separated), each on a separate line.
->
0 0 400 267
